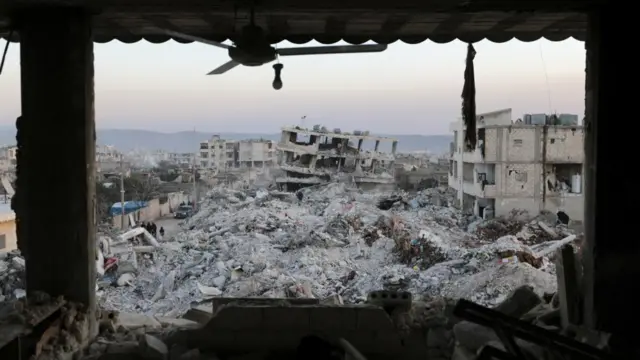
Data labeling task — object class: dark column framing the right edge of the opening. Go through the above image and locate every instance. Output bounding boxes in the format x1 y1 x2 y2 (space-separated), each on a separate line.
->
582 6 640 358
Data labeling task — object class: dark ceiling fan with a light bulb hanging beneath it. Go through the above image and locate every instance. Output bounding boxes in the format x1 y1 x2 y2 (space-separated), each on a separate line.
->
164 9 387 90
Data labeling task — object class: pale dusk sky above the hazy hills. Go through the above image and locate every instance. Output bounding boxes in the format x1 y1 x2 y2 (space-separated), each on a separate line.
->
0 40 585 134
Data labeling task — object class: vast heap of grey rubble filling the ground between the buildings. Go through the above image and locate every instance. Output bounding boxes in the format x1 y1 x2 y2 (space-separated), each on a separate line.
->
0 184 575 316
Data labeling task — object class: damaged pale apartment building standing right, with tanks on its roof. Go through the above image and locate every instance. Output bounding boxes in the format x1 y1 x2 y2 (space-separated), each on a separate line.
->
449 109 584 221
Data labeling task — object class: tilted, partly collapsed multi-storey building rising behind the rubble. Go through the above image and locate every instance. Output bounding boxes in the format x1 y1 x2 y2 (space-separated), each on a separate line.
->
276 125 398 191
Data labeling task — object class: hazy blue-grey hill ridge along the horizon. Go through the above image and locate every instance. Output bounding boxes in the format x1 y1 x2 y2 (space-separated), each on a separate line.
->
0 127 453 154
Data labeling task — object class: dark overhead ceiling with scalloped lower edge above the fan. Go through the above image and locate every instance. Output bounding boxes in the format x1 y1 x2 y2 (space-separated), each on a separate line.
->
0 0 598 44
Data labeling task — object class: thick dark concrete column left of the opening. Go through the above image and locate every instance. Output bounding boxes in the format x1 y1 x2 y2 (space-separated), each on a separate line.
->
14 8 96 319
